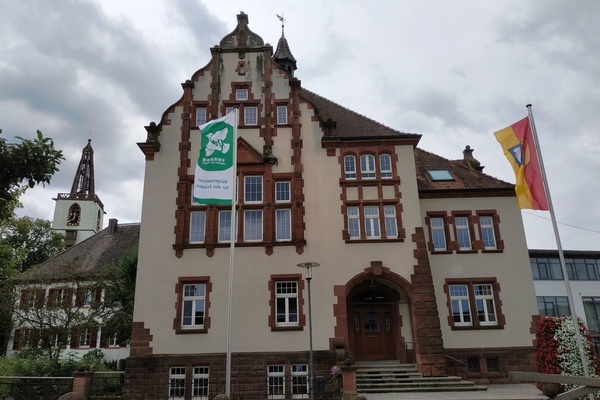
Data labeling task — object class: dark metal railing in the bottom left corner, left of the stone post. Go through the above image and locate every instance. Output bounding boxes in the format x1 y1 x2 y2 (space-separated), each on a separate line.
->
0 376 73 400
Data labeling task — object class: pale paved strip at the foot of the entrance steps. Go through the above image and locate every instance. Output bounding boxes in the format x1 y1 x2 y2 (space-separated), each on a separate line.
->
365 383 548 400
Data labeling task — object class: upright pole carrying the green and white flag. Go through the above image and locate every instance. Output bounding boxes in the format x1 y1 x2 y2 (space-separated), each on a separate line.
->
225 107 239 398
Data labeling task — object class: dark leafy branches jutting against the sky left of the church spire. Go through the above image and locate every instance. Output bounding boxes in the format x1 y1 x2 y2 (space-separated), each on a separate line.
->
0 129 64 221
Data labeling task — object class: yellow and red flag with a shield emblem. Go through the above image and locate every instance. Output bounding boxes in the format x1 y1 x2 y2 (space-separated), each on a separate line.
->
494 117 548 210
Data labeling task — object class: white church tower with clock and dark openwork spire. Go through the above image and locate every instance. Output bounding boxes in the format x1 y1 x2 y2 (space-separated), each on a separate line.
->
52 139 104 247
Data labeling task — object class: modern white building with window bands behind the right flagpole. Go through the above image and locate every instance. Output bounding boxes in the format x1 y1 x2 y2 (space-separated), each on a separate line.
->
529 250 600 354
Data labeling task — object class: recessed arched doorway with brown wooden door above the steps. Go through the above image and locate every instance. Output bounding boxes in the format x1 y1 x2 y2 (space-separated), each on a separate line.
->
347 278 407 362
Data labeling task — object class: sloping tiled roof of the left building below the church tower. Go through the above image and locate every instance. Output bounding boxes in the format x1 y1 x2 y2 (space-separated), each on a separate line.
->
15 220 140 281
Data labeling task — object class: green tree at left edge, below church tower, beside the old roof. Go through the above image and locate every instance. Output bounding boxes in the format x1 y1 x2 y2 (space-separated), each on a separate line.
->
0 216 65 281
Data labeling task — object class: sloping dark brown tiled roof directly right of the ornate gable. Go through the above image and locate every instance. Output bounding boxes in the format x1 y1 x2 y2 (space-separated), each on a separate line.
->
299 88 421 141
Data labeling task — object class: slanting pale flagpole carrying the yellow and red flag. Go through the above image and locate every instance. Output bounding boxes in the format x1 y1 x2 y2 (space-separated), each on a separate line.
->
523 104 593 380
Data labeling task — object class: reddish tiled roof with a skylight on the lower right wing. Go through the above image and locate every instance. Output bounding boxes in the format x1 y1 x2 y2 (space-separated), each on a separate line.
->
415 148 515 197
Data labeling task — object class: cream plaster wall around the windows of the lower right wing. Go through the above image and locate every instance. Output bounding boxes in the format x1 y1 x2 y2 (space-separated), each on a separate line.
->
421 197 538 348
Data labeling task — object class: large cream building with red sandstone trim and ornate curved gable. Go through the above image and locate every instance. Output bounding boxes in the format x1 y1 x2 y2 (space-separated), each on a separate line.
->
126 13 538 399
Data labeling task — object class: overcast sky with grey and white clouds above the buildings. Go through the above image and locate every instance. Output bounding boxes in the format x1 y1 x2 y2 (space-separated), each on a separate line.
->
0 0 600 250
